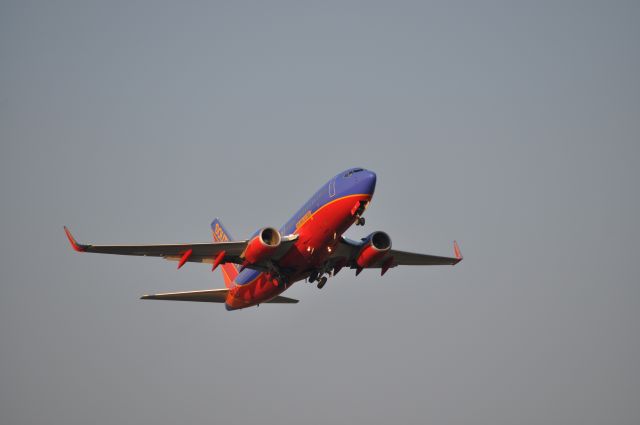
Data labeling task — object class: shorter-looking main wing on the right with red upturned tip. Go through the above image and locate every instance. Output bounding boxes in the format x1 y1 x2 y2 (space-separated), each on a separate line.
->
331 237 462 271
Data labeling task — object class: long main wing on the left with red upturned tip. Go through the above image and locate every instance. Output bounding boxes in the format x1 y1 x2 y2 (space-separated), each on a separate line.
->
64 226 298 269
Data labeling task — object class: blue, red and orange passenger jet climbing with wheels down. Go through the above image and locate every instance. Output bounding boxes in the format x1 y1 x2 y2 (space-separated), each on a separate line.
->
64 168 462 310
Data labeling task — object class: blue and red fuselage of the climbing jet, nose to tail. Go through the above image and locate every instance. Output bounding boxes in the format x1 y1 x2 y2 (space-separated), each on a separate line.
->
226 168 376 310
